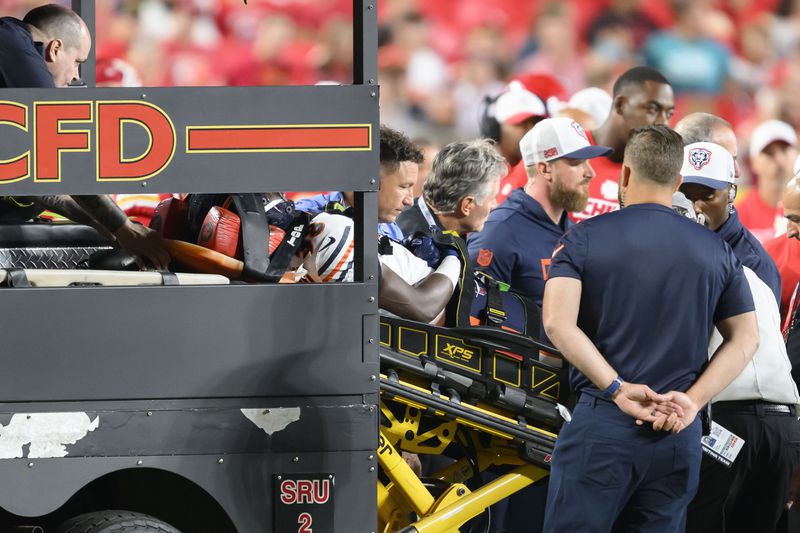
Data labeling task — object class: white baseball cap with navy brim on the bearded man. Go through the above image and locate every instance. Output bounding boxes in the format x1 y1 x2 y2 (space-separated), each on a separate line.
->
519 117 614 167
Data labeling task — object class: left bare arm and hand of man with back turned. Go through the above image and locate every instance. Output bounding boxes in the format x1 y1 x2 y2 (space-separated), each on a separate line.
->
542 277 675 423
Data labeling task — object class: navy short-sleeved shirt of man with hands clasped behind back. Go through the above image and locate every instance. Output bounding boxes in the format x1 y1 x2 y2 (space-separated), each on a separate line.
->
550 204 754 395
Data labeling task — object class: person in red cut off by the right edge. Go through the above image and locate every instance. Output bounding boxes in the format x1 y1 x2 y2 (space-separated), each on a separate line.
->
764 171 800 323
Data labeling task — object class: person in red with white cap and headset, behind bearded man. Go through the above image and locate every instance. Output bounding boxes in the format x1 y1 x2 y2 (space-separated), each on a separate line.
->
483 81 547 205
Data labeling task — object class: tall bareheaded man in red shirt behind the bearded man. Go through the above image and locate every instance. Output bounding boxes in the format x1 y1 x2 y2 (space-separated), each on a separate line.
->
571 67 675 222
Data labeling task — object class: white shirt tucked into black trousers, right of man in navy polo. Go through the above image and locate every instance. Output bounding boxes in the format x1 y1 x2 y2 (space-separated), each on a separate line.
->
708 267 800 408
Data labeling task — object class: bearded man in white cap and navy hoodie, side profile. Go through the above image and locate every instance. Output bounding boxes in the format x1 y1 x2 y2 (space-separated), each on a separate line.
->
467 118 611 307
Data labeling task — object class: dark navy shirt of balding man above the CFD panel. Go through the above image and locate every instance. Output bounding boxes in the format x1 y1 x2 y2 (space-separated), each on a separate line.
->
0 17 55 89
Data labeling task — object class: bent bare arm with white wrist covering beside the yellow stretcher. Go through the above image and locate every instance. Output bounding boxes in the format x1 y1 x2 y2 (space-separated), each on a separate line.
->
378 257 460 322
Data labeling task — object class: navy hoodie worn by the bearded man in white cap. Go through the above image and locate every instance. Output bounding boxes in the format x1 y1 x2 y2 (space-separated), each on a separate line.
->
467 189 572 307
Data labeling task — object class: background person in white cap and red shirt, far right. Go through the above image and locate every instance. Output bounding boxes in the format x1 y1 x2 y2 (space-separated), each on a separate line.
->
736 120 797 243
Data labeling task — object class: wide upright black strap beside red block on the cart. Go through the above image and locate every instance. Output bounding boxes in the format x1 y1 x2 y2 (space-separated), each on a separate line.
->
232 194 269 281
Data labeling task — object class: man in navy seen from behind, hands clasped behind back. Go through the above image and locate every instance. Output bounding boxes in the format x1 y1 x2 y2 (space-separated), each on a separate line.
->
543 125 758 533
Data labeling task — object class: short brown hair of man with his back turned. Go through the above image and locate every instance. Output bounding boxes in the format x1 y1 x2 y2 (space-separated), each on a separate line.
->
625 124 683 187
